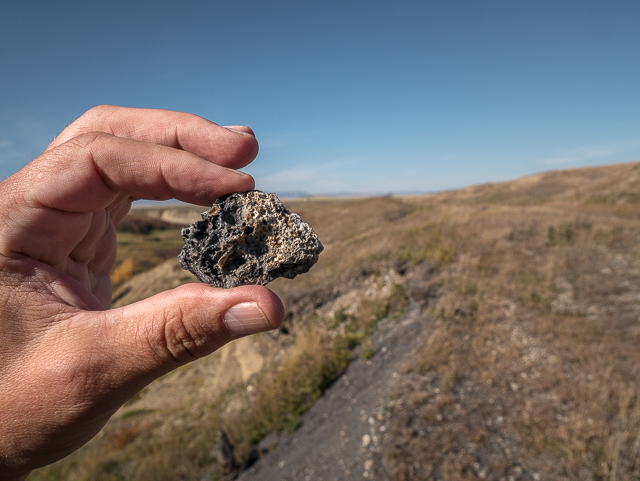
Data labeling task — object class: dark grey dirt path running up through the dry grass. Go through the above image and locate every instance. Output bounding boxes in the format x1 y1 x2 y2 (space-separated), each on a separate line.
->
238 305 429 481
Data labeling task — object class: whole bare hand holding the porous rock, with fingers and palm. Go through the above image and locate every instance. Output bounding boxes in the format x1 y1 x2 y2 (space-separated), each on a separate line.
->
0 106 283 481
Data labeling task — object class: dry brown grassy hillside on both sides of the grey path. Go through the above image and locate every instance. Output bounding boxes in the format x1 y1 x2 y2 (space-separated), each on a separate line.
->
30 164 640 480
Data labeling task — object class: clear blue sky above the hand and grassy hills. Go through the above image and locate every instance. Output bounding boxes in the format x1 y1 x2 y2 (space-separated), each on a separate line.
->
0 0 640 194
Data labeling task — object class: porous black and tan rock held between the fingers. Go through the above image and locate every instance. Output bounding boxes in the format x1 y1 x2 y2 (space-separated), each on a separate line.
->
178 190 324 287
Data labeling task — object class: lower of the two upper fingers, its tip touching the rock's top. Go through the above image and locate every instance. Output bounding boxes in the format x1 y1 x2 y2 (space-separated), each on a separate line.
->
30 132 254 212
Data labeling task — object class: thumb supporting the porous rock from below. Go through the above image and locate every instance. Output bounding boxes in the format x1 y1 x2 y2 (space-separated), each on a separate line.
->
105 284 284 389
